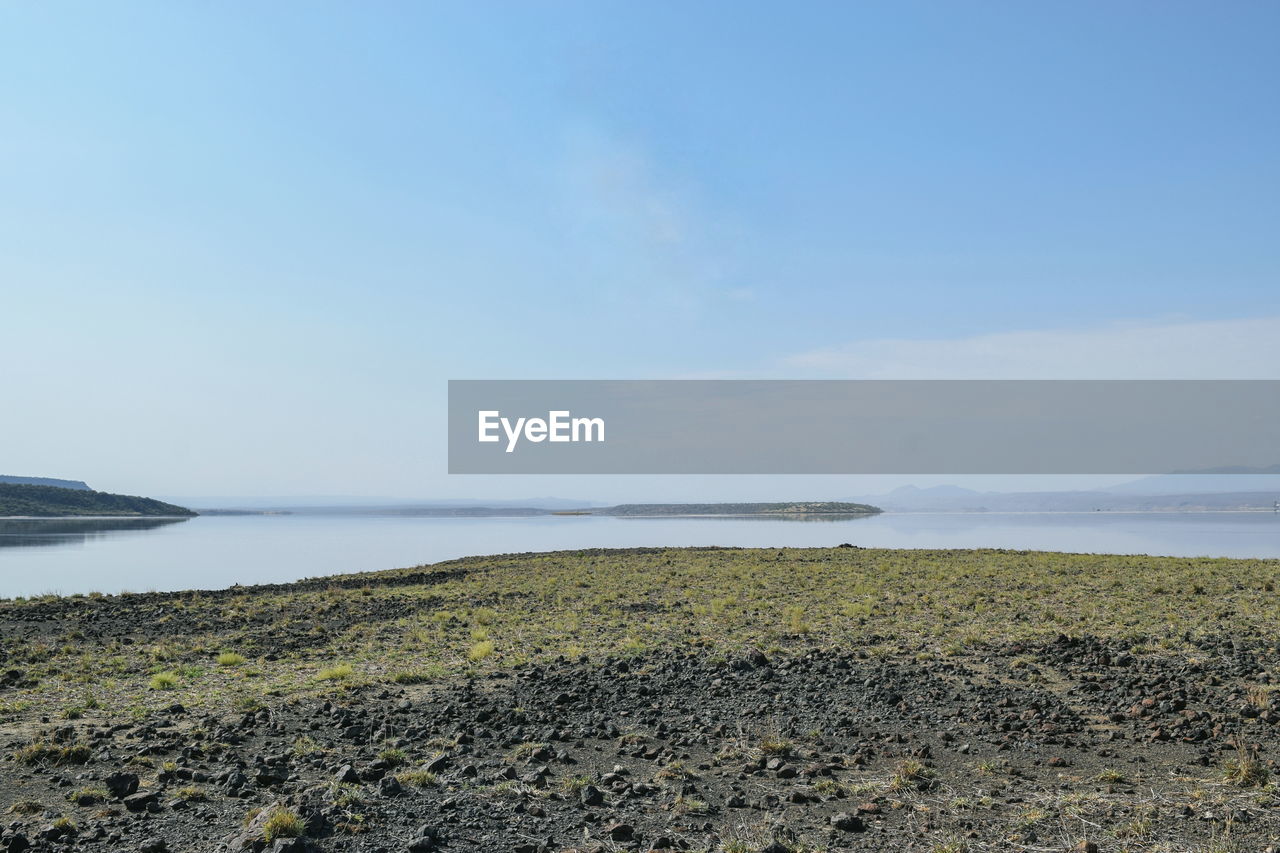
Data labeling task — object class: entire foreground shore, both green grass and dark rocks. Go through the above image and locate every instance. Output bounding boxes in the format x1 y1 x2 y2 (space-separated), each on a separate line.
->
0 547 1280 853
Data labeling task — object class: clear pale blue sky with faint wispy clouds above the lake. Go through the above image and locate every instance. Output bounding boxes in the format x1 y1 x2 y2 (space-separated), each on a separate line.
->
0 0 1280 501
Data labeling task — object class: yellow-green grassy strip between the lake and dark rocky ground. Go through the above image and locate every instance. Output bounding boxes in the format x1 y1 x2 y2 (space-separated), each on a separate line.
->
0 548 1280 719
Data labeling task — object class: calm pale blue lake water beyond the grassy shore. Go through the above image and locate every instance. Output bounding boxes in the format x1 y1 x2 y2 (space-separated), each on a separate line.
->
0 512 1280 597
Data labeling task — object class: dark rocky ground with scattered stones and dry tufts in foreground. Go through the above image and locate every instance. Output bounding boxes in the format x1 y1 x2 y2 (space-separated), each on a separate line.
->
0 548 1280 853
